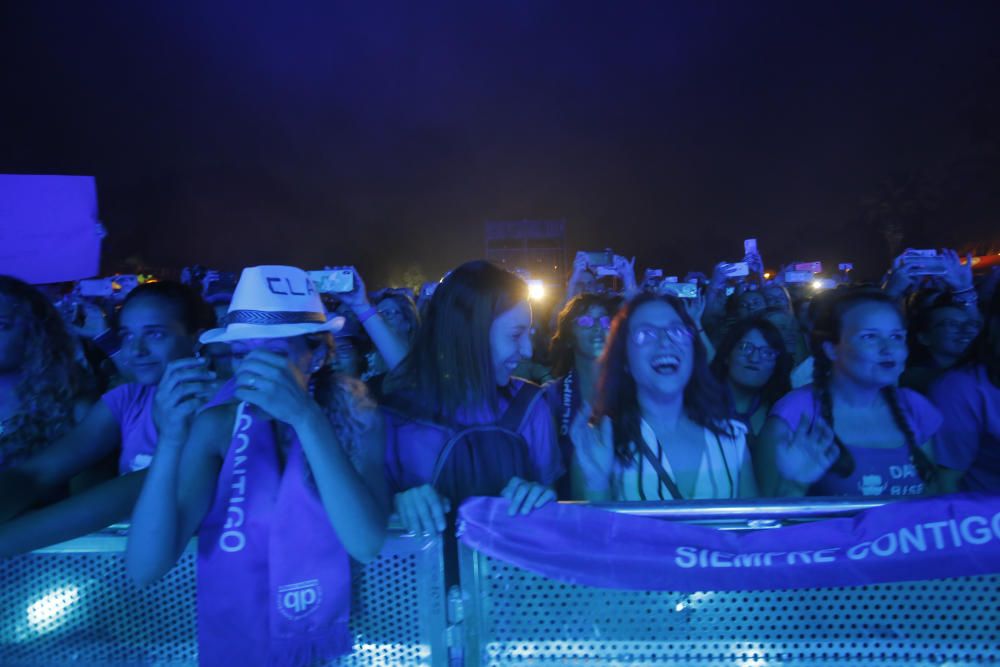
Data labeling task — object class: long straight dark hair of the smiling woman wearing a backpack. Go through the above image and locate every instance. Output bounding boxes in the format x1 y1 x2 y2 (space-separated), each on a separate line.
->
386 260 528 424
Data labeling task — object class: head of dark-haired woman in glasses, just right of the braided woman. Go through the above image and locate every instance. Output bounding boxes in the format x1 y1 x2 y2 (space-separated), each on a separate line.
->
899 292 983 395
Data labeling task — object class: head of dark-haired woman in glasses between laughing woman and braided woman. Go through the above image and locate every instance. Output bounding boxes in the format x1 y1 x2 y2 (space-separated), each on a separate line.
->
711 318 792 449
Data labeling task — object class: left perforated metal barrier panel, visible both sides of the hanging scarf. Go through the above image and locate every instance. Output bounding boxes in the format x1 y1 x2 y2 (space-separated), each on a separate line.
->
0 534 447 667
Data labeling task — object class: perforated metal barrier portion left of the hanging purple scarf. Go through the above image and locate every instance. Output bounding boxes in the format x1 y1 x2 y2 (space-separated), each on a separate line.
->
0 538 198 665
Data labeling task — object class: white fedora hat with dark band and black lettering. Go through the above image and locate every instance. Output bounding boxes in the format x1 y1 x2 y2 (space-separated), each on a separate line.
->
198 266 344 345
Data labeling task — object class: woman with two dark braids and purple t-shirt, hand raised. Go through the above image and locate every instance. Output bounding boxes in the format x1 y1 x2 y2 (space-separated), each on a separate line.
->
754 288 941 496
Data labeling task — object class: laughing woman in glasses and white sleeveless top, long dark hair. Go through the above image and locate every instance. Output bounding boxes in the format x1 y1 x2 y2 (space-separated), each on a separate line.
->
571 294 757 501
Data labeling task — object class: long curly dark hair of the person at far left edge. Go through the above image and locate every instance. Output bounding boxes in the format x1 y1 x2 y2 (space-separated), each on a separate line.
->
0 276 81 464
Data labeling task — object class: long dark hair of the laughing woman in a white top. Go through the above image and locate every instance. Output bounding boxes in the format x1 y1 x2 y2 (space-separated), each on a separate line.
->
592 293 733 463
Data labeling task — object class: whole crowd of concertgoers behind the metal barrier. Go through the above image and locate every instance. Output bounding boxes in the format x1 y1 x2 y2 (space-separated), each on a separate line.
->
0 251 1000 664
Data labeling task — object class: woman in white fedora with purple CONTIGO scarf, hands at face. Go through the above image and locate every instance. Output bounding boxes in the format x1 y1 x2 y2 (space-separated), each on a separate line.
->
126 266 388 665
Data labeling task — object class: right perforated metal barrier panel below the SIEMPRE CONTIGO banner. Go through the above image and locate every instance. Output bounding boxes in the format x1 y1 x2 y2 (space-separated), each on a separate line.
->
460 546 1000 665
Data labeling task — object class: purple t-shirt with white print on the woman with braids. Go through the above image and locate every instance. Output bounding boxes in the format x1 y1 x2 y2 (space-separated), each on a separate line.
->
771 385 941 496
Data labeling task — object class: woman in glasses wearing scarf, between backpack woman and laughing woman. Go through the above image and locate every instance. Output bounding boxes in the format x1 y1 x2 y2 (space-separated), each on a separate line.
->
545 293 620 500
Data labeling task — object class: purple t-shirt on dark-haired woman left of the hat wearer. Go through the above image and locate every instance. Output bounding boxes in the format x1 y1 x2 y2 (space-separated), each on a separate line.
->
101 382 157 475
